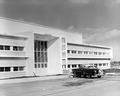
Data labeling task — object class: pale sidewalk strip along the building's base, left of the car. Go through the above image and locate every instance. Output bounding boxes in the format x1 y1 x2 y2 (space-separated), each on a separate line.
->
0 75 69 84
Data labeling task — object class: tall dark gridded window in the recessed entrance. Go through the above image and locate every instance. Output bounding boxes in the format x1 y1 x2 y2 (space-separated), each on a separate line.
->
34 40 47 68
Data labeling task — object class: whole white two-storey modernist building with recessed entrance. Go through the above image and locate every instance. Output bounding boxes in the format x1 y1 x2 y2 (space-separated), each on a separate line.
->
0 18 112 78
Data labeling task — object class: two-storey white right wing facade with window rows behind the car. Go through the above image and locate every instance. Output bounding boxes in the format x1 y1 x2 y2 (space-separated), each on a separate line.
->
67 43 112 69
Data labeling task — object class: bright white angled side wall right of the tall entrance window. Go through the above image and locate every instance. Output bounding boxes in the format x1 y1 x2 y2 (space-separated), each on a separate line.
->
48 38 62 74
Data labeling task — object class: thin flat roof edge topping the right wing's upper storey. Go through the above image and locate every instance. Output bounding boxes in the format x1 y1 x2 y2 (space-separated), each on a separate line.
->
67 43 112 49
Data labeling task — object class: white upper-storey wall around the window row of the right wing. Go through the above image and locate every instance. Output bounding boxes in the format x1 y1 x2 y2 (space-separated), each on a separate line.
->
67 45 112 58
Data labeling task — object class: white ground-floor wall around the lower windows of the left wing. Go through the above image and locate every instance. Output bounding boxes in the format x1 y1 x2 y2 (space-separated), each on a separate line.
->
0 58 26 79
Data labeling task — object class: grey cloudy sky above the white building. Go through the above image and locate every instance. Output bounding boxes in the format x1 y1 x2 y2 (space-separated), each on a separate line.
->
0 0 120 60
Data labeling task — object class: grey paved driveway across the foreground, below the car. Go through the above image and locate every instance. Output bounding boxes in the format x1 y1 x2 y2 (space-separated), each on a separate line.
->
0 76 120 96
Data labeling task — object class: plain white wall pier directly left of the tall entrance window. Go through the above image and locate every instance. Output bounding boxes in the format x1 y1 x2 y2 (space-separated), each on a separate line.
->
19 32 35 76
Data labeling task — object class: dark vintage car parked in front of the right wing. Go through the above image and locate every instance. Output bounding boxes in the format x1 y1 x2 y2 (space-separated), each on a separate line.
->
72 67 104 78
